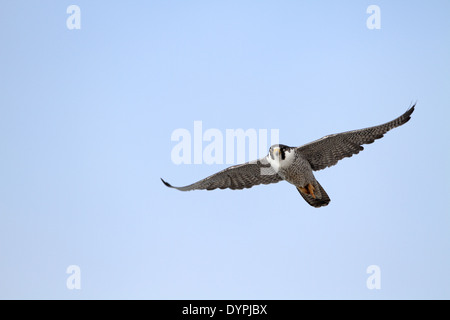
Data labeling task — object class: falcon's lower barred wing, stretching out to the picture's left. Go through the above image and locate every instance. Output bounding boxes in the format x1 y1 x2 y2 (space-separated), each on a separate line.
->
161 158 283 191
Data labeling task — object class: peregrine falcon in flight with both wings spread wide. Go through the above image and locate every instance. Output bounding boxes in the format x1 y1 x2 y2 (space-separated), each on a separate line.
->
161 104 415 208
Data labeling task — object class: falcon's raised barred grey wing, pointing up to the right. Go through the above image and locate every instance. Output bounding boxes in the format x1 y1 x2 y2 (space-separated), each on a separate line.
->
296 104 416 170
